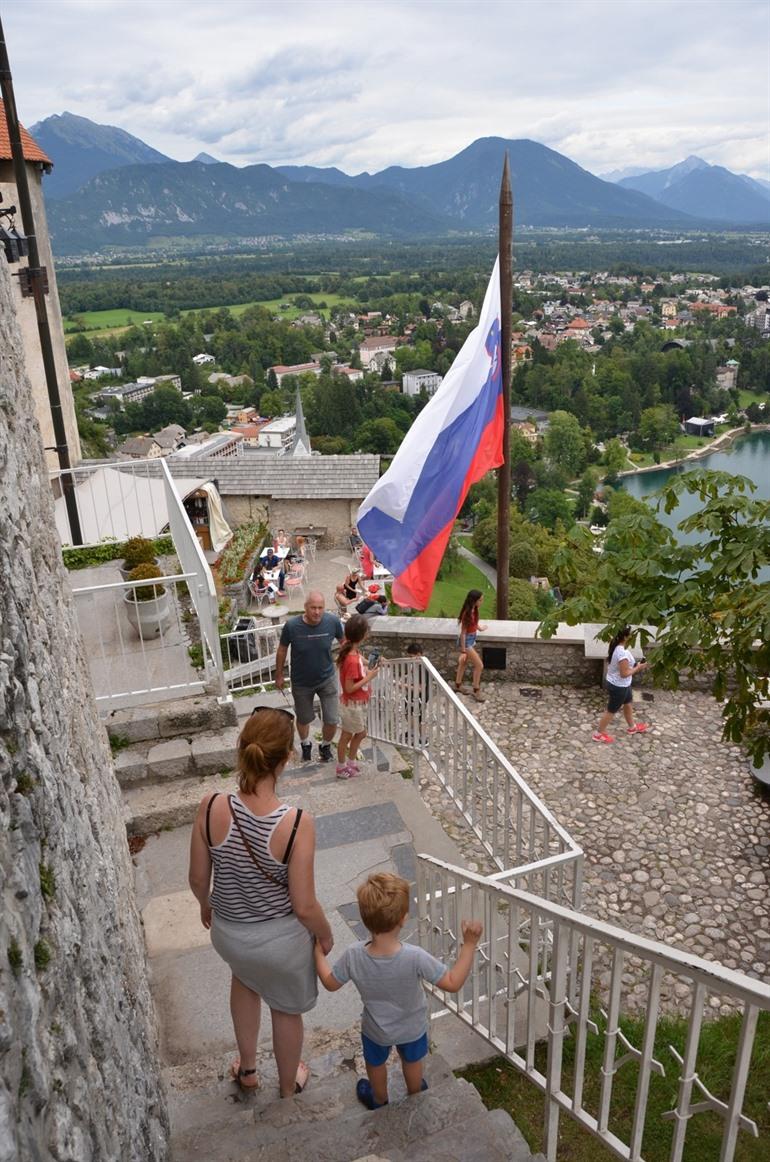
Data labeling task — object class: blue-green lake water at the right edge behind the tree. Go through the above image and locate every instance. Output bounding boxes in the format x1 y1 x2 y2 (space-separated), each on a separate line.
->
623 431 770 581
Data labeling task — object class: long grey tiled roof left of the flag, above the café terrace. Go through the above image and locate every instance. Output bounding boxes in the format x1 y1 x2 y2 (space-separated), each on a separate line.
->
166 453 380 500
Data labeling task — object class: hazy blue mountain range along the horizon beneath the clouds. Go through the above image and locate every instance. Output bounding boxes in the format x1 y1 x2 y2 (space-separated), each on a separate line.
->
30 113 770 253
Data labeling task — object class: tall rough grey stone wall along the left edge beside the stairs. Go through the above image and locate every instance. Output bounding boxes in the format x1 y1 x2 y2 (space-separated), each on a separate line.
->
0 261 168 1162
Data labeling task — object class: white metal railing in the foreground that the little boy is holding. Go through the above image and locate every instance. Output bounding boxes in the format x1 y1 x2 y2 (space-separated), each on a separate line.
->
417 855 770 1162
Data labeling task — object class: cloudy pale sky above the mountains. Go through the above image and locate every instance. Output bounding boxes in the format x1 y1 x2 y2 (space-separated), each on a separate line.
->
0 0 770 179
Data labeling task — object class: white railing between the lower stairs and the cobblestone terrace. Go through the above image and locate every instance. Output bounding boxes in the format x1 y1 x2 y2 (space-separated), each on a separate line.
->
369 658 583 908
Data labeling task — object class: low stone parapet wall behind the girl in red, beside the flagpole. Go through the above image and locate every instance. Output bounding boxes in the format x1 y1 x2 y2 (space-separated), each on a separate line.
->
372 617 603 686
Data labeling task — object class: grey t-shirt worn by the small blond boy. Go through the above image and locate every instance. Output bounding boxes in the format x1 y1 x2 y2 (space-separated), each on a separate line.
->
332 940 447 1045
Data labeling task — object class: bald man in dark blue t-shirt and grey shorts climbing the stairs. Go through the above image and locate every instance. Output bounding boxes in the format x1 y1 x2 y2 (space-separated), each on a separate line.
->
275 590 344 762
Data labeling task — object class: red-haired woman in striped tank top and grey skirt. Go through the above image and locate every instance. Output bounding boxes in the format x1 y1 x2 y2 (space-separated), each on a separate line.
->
189 706 333 1097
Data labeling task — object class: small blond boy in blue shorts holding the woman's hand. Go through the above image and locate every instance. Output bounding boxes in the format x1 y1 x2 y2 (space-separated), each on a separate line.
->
315 872 482 1110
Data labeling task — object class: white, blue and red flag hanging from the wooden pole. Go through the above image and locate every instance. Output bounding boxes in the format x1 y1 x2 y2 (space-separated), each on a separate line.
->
358 261 503 609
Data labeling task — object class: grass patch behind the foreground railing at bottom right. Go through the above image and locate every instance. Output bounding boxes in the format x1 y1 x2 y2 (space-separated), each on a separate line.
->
460 1012 770 1162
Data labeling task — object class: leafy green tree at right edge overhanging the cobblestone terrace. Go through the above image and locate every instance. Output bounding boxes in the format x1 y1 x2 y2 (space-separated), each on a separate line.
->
541 469 770 765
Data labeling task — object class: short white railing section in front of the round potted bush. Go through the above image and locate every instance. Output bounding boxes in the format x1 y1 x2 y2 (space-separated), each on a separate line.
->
72 573 206 706
